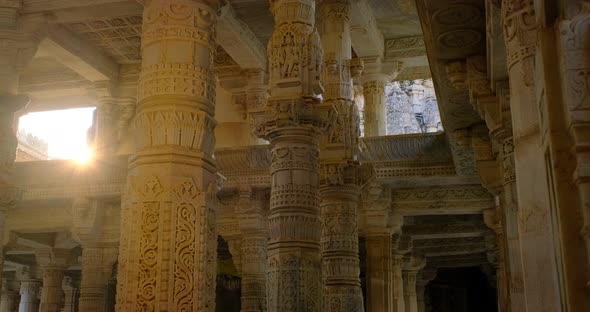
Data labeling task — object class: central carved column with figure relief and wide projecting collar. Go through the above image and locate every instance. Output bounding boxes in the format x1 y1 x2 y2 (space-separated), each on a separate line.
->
252 0 331 312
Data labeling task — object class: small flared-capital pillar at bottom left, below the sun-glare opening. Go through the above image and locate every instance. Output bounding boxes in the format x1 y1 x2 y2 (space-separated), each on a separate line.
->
36 248 73 312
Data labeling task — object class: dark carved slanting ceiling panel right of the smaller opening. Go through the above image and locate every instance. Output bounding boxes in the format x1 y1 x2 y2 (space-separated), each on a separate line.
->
418 0 486 131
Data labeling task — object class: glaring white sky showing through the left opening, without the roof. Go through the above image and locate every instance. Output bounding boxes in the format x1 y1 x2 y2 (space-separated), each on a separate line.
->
19 107 95 162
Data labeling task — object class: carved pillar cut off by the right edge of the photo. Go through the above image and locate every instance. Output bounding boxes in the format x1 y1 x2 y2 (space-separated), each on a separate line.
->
555 1 590 292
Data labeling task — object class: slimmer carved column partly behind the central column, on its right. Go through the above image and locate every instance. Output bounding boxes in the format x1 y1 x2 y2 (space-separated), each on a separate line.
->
318 0 364 312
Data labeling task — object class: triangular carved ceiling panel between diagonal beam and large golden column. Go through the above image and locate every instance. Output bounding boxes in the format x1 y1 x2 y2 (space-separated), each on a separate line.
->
65 15 142 64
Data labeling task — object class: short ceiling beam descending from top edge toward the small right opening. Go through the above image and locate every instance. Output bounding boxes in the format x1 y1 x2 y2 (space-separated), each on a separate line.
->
350 0 385 57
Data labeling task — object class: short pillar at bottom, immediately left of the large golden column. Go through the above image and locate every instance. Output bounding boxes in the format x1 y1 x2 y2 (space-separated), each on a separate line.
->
78 244 118 312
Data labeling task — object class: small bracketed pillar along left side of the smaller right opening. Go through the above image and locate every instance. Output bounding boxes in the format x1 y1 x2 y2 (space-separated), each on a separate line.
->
362 57 401 137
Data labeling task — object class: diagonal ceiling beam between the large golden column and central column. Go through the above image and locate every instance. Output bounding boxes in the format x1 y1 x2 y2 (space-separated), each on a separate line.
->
217 3 267 70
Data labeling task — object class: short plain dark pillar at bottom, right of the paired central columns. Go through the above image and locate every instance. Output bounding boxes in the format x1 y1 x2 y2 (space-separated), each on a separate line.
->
365 232 393 312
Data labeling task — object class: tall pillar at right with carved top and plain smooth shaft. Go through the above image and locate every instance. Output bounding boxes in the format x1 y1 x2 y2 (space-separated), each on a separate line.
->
502 0 561 311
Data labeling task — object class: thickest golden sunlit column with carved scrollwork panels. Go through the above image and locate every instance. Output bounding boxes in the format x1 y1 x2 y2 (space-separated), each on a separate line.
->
117 0 219 311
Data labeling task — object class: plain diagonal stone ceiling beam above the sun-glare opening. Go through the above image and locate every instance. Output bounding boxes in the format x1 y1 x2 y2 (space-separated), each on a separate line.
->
38 25 119 81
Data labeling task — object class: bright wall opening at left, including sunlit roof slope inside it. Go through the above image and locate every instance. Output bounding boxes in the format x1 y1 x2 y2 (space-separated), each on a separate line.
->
16 107 95 163
